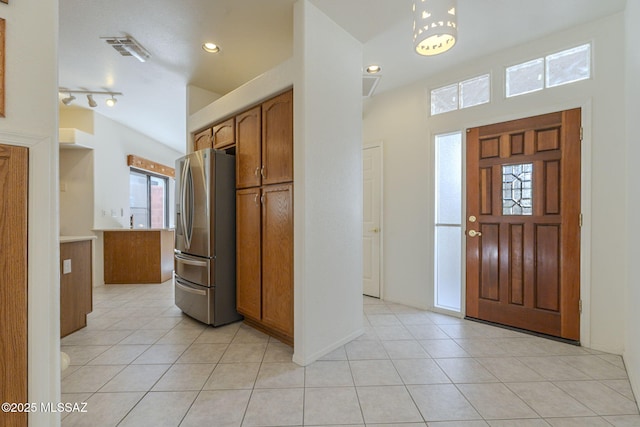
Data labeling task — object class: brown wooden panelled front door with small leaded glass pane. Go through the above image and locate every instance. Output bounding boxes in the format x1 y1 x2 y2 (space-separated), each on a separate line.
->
466 109 581 341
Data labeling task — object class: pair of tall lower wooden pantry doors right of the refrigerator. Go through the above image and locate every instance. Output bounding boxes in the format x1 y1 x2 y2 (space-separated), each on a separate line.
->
236 184 293 344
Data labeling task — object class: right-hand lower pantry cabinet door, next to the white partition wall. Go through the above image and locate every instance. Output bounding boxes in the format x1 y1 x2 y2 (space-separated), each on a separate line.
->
262 184 293 337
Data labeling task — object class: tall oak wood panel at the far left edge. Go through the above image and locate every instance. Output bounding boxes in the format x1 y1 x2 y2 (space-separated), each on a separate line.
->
0 145 29 427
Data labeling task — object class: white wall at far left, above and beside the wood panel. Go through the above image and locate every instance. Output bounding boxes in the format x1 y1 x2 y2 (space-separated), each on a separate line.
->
0 0 60 426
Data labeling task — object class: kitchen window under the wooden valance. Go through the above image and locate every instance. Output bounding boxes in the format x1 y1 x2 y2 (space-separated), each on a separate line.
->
129 168 169 228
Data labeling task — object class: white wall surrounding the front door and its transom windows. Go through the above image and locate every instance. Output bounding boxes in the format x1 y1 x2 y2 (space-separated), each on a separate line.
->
364 14 628 354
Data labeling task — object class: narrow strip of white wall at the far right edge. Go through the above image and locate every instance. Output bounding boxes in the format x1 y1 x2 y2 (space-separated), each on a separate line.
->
624 1 640 398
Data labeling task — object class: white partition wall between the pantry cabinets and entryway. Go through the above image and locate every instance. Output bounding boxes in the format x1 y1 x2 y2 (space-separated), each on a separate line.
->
293 1 362 365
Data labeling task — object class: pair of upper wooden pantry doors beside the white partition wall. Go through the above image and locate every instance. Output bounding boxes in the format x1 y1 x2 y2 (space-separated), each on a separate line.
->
236 91 293 188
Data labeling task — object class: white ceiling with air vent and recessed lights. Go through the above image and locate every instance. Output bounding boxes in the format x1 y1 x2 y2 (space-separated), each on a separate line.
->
59 0 625 151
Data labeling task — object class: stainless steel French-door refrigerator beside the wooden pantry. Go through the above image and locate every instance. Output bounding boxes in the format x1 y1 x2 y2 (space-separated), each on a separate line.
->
174 149 242 326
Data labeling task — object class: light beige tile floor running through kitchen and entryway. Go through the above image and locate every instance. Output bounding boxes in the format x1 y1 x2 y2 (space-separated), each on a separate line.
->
62 282 640 427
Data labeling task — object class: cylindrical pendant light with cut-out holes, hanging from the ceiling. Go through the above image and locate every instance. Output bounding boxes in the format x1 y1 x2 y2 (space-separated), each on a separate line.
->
413 0 458 56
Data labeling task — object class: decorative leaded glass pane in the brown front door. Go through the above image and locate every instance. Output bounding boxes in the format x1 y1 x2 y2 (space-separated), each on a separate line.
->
502 163 533 215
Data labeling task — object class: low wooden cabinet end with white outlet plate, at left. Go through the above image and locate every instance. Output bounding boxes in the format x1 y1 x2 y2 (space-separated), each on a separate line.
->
60 240 93 337
